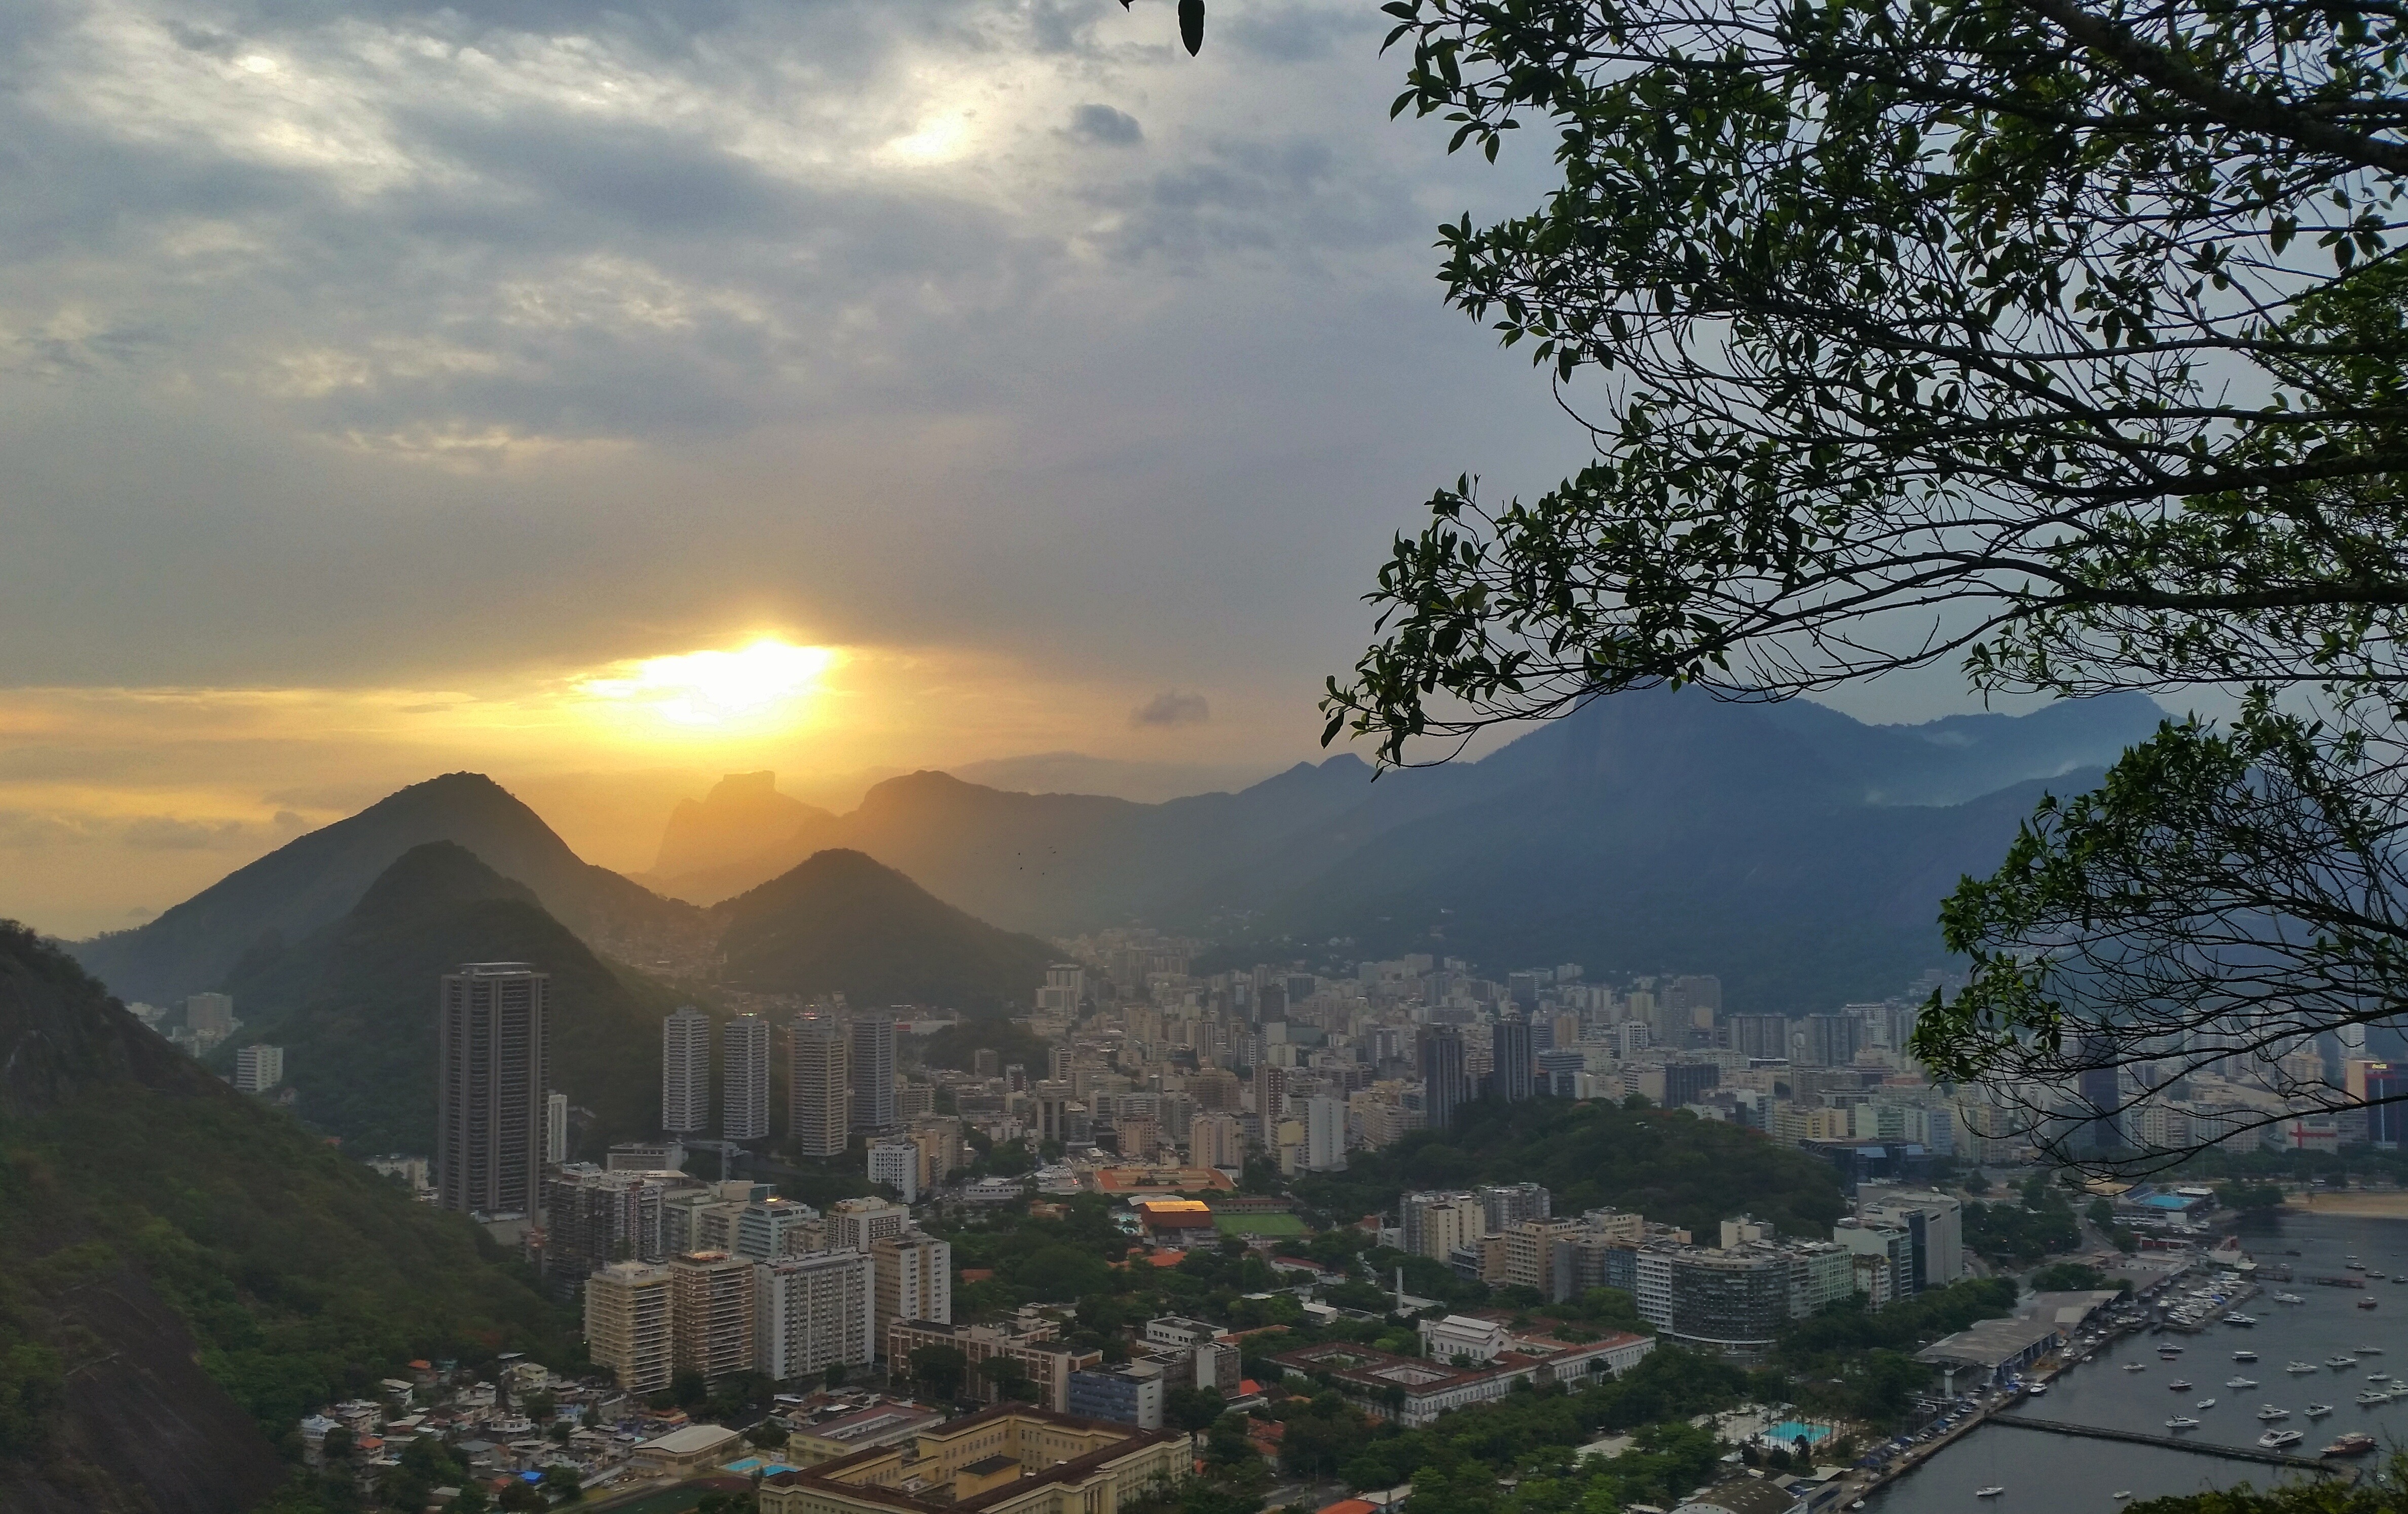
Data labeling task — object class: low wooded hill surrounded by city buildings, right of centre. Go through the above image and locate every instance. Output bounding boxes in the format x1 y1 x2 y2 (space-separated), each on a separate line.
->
1295 1097 1847 1239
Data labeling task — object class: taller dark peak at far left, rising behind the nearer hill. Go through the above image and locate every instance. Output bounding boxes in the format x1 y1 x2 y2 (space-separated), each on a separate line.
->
75 773 693 1018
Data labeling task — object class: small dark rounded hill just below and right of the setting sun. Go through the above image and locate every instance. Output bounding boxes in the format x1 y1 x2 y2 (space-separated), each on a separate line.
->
711 852 1059 1013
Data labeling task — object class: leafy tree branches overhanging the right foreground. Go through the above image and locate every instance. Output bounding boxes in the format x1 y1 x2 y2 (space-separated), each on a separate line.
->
1324 0 2408 1169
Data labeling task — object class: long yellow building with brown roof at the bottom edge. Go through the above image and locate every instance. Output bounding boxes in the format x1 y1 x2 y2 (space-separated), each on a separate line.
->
761 1403 1194 1514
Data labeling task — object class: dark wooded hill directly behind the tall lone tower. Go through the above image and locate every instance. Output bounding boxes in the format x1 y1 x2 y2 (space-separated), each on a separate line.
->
217 840 693 1153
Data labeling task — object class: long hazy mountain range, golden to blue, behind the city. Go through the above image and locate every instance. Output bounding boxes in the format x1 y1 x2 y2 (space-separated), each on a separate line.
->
621 691 2162 1008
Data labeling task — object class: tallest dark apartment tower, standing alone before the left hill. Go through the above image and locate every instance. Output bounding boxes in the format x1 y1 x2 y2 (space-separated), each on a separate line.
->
436 963 551 1216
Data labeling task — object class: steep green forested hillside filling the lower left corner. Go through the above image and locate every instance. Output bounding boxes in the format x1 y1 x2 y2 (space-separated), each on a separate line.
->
0 922 580 1514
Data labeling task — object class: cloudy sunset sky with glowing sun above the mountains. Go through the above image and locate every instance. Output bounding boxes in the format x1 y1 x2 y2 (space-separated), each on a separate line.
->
0 0 1993 936
